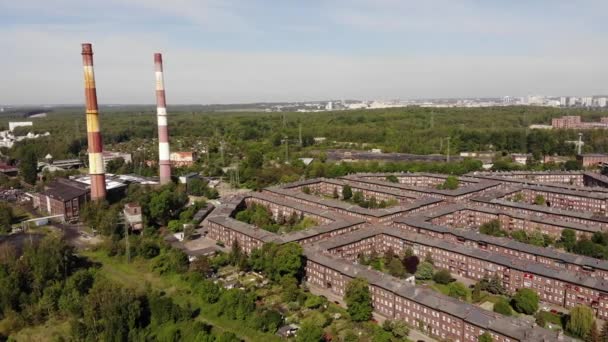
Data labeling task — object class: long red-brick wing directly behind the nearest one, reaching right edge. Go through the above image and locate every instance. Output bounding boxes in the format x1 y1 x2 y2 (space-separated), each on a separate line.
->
321 227 608 319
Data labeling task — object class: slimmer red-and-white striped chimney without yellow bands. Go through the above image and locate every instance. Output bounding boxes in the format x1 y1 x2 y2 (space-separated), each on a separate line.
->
154 53 171 184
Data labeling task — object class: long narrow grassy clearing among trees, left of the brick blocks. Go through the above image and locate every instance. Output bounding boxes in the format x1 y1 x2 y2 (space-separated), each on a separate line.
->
83 248 280 342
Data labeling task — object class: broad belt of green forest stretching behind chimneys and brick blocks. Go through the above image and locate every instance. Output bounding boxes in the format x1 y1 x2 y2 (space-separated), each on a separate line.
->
0 106 608 187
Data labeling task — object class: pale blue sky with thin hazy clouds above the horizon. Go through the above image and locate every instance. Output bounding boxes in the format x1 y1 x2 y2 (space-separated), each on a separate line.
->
0 0 608 104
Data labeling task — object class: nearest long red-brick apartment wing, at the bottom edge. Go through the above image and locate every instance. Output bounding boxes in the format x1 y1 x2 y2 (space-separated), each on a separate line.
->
305 248 572 342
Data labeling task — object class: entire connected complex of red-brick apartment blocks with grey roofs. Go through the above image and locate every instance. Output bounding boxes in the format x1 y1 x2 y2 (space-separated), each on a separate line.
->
205 173 608 341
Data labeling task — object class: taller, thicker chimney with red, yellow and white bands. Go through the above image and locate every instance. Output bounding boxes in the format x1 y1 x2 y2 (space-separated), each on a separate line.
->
82 43 106 201
